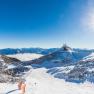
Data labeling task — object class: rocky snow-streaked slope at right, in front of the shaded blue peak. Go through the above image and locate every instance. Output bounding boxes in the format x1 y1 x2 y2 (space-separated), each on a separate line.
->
48 53 94 83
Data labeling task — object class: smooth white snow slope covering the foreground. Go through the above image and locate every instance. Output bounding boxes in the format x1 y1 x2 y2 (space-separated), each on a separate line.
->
0 68 94 94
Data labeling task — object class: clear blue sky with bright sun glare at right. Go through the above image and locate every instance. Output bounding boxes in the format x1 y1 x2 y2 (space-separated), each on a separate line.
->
0 0 94 48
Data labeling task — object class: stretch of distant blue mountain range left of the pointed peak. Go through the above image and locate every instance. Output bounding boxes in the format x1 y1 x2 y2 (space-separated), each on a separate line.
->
0 48 58 55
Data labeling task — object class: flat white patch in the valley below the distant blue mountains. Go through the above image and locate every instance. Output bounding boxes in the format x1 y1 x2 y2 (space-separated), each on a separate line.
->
7 53 43 61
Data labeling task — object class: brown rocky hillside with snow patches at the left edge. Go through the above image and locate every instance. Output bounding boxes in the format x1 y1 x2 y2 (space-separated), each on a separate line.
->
0 55 29 82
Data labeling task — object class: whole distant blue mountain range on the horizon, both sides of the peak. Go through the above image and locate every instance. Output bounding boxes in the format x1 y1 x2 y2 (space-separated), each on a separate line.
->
0 48 94 55
